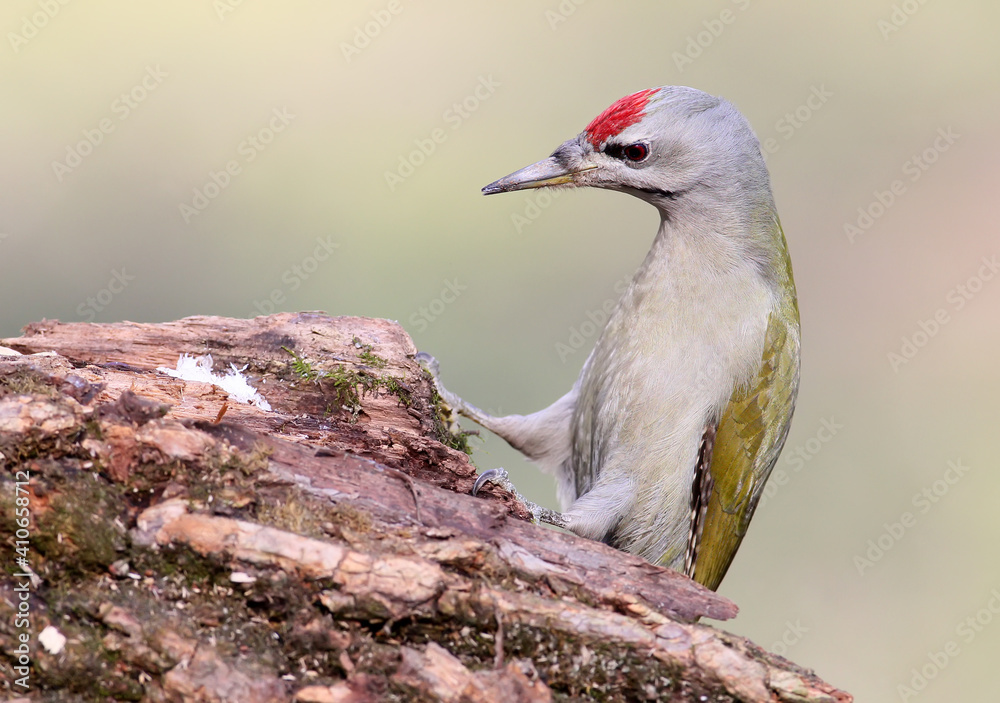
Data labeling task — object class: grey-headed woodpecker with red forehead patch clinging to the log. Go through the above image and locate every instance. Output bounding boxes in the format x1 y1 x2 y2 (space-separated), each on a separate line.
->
420 86 800 590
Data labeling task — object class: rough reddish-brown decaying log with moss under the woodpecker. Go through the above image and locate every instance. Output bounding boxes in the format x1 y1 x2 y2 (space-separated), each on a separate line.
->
0 313 851 702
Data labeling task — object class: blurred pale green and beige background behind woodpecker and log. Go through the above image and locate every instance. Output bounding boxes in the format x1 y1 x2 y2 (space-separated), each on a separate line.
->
0 0 1000 701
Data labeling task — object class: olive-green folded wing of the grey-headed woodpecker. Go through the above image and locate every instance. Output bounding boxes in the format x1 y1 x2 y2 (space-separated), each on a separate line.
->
692 306 799 591
